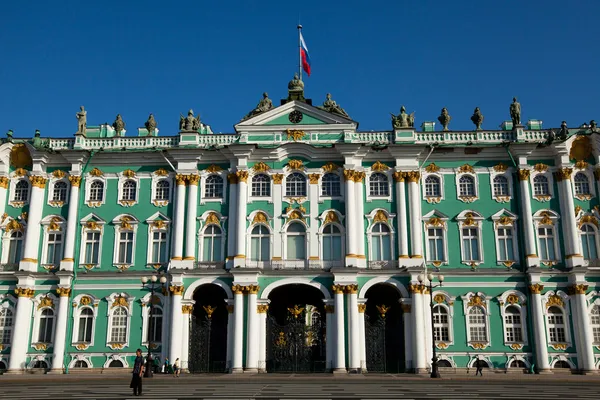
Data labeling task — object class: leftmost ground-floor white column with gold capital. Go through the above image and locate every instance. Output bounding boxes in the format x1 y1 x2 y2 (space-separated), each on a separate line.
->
8 288 35 373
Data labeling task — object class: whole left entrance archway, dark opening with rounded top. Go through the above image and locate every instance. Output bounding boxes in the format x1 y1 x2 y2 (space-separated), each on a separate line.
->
188 284 228 373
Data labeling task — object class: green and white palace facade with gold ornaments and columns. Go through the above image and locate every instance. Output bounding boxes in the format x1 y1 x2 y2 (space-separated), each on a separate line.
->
0 84 600 373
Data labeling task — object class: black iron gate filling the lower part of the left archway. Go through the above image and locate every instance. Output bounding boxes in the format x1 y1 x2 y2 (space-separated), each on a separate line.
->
188 315 227 373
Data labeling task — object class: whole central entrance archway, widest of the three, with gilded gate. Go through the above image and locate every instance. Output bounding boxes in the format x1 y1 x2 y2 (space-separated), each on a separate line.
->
266 284 327 373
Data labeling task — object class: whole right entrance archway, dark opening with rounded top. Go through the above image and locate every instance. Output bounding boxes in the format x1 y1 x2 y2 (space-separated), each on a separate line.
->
365 283 405 373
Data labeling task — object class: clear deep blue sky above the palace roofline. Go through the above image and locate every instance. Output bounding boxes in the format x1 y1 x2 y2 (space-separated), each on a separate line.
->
0 0 600 137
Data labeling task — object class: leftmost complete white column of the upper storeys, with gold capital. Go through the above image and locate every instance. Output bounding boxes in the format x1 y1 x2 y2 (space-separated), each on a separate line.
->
19 176 46 271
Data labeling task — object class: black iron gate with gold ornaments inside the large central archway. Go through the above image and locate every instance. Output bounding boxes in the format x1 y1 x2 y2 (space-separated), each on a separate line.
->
267 306 326 372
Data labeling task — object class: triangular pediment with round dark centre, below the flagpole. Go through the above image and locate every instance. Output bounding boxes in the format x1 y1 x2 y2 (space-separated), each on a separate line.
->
235 101 358 132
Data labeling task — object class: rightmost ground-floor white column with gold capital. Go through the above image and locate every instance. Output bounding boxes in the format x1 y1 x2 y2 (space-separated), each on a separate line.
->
570 284 597 373
